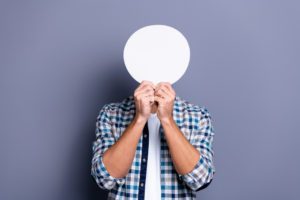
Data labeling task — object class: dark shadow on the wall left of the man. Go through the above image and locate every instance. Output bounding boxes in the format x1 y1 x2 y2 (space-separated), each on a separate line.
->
66 62 138 200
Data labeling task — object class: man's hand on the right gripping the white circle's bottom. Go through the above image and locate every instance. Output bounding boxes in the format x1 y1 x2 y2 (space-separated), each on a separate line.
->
154 82 176 123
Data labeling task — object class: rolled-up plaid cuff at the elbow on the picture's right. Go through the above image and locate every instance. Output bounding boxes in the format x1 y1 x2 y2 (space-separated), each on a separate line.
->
178 155 214 191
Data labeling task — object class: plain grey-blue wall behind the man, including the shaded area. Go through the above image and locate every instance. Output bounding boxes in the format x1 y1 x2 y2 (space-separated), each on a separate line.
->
0 0 300 200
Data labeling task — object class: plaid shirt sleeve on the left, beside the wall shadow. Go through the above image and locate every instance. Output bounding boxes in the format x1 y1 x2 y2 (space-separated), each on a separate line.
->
91 104 125 190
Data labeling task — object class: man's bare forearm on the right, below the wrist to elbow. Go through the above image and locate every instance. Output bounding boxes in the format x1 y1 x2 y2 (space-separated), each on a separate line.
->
162 118 200 174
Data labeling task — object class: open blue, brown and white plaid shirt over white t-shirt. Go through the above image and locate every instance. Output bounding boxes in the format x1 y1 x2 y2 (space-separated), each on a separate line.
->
91 95 215 199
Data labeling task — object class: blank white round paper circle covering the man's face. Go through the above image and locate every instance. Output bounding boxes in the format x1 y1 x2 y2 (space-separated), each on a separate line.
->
123 25 190 84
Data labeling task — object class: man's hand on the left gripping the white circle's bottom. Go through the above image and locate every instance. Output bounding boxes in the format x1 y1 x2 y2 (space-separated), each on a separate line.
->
134 80 155 122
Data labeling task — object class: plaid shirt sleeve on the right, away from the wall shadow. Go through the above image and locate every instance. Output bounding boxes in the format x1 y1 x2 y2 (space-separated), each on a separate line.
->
178 108 215 191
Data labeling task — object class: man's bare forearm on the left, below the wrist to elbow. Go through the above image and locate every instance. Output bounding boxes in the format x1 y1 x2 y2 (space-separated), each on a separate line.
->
103 117 146 178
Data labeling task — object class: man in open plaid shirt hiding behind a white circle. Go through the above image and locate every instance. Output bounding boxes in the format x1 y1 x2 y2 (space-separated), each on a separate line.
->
91 81 215 200
